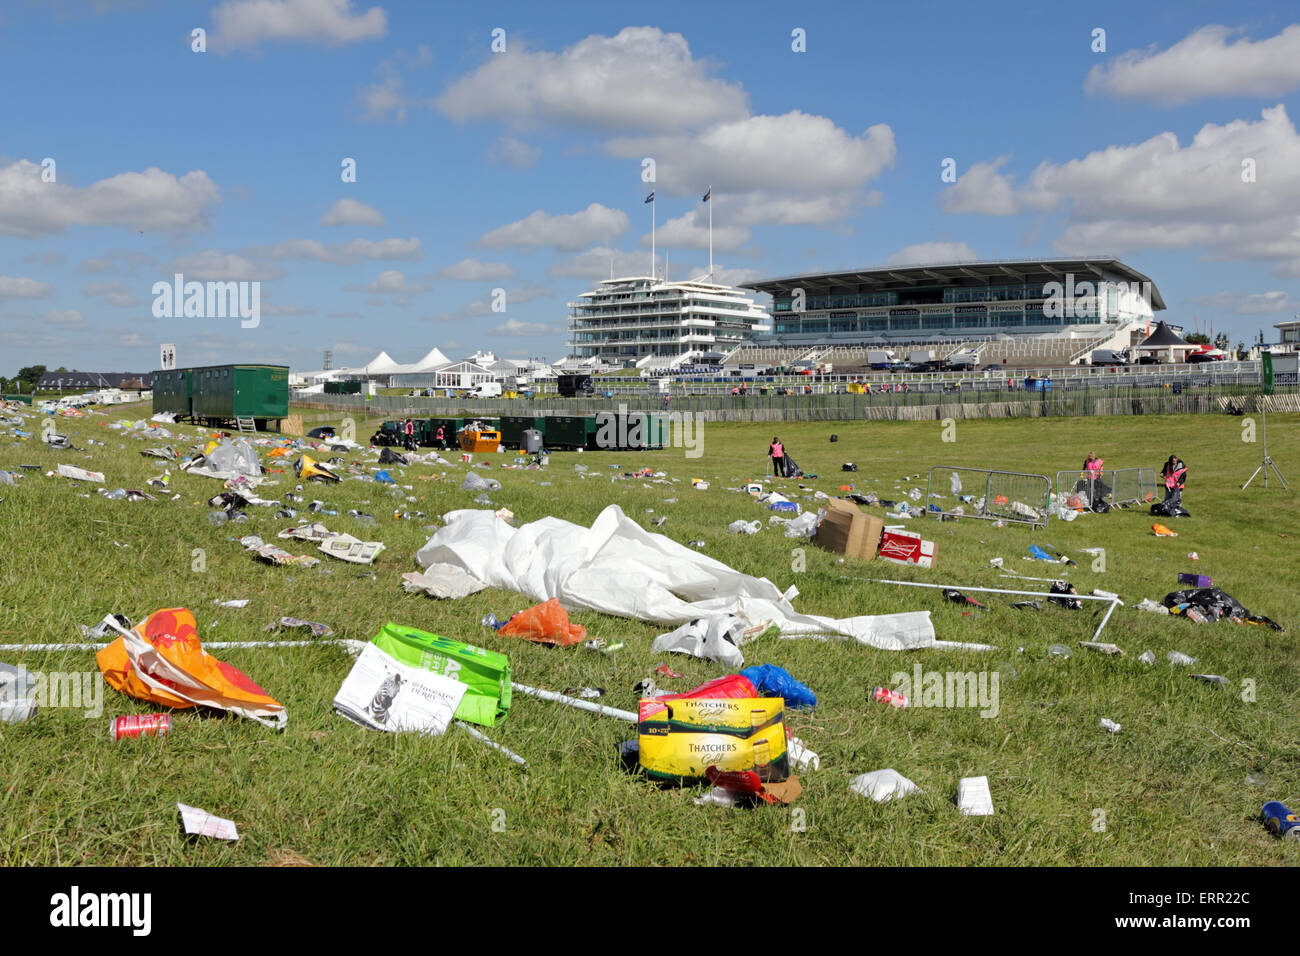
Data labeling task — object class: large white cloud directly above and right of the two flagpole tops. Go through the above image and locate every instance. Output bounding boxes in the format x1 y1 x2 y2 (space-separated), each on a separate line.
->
606 109 897 226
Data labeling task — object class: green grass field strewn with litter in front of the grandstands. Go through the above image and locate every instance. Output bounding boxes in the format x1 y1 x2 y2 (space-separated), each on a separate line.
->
0 406 1300 866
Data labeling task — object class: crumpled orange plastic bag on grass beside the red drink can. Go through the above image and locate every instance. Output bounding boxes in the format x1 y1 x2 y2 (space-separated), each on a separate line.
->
95 607 289 730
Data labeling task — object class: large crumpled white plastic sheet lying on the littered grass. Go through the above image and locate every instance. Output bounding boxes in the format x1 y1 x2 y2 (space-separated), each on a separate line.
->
416 505 935 650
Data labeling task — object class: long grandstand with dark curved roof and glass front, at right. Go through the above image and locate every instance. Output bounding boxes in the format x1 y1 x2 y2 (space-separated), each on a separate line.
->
741 256 1165 365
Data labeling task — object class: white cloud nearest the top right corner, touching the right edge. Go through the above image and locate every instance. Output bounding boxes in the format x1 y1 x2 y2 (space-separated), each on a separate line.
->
1084 25 1300 104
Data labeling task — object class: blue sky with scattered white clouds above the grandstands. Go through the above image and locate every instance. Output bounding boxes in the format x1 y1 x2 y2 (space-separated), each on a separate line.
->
0 0 1300 375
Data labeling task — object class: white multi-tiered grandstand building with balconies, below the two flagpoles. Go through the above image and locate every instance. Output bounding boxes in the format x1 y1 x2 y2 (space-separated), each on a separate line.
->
568 276 771 364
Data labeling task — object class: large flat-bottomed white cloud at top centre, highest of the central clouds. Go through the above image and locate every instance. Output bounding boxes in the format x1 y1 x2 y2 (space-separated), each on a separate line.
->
434 26 746 130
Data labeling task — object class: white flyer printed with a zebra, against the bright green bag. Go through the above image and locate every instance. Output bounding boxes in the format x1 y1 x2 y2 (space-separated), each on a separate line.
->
334 644 467 735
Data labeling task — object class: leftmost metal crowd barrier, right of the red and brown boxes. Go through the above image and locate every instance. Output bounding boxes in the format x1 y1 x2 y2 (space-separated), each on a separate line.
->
926 464 1052 528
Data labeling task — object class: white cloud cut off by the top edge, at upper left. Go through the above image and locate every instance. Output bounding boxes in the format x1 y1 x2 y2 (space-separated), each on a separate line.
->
209 0 389 49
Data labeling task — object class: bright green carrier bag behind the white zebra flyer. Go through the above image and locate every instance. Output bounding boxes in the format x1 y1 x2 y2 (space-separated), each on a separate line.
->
371 620 510 727
